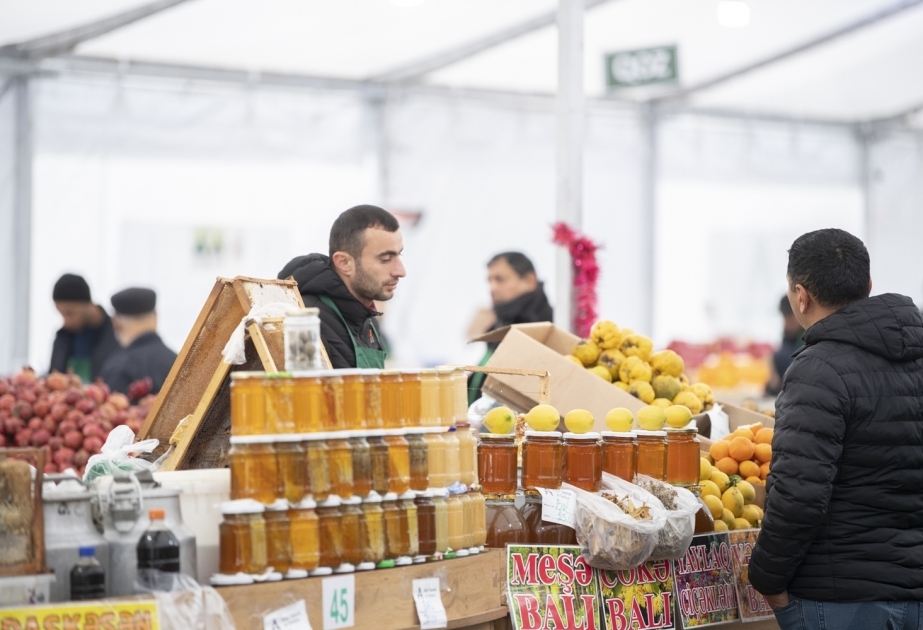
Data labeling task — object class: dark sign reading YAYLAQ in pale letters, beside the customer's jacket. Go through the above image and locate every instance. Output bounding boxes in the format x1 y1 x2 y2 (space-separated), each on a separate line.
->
673 532 740 628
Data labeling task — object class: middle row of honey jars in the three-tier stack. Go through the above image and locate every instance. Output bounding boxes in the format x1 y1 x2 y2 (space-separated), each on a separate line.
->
229 422 478 505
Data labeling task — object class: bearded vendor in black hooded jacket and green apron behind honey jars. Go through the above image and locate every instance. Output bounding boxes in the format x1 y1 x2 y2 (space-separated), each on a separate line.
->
279 206 407 369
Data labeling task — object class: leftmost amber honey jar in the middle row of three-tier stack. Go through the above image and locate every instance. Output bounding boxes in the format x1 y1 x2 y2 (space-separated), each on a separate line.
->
229 436 281 504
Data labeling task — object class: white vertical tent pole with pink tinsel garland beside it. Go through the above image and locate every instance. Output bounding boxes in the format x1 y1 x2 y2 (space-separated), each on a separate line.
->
554 0 586 330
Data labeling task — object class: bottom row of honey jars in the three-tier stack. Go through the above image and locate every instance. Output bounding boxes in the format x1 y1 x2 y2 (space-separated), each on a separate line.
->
213 490 486 582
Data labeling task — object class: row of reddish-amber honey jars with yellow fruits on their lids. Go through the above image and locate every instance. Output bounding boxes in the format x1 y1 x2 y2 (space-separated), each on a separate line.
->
478 427 699 495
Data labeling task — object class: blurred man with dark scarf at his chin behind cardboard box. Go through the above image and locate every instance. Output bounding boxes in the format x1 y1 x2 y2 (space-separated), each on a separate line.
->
468 252 554 405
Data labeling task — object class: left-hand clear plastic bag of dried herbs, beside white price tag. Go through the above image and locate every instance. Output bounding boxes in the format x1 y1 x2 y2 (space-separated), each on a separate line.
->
561 483 665 571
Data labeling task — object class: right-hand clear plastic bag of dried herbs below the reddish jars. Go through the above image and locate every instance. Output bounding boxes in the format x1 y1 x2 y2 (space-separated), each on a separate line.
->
600 472 701 560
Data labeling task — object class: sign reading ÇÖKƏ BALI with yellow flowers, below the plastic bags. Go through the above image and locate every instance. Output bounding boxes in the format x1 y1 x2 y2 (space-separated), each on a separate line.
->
599 560 676 630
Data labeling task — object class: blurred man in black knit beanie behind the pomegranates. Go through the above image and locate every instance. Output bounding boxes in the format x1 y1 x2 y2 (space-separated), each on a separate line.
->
49 273 119 383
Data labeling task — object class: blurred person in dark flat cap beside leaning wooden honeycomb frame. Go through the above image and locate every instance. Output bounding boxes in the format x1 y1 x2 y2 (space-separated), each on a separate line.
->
102 287 176 400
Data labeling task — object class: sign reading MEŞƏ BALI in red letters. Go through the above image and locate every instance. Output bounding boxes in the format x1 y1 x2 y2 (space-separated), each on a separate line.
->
506 545 600 630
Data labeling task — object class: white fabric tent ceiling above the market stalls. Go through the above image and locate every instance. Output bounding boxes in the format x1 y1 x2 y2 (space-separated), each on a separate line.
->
0 0 923 121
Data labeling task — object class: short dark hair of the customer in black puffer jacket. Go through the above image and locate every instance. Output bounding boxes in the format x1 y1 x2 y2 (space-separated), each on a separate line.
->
788 228 871 309
